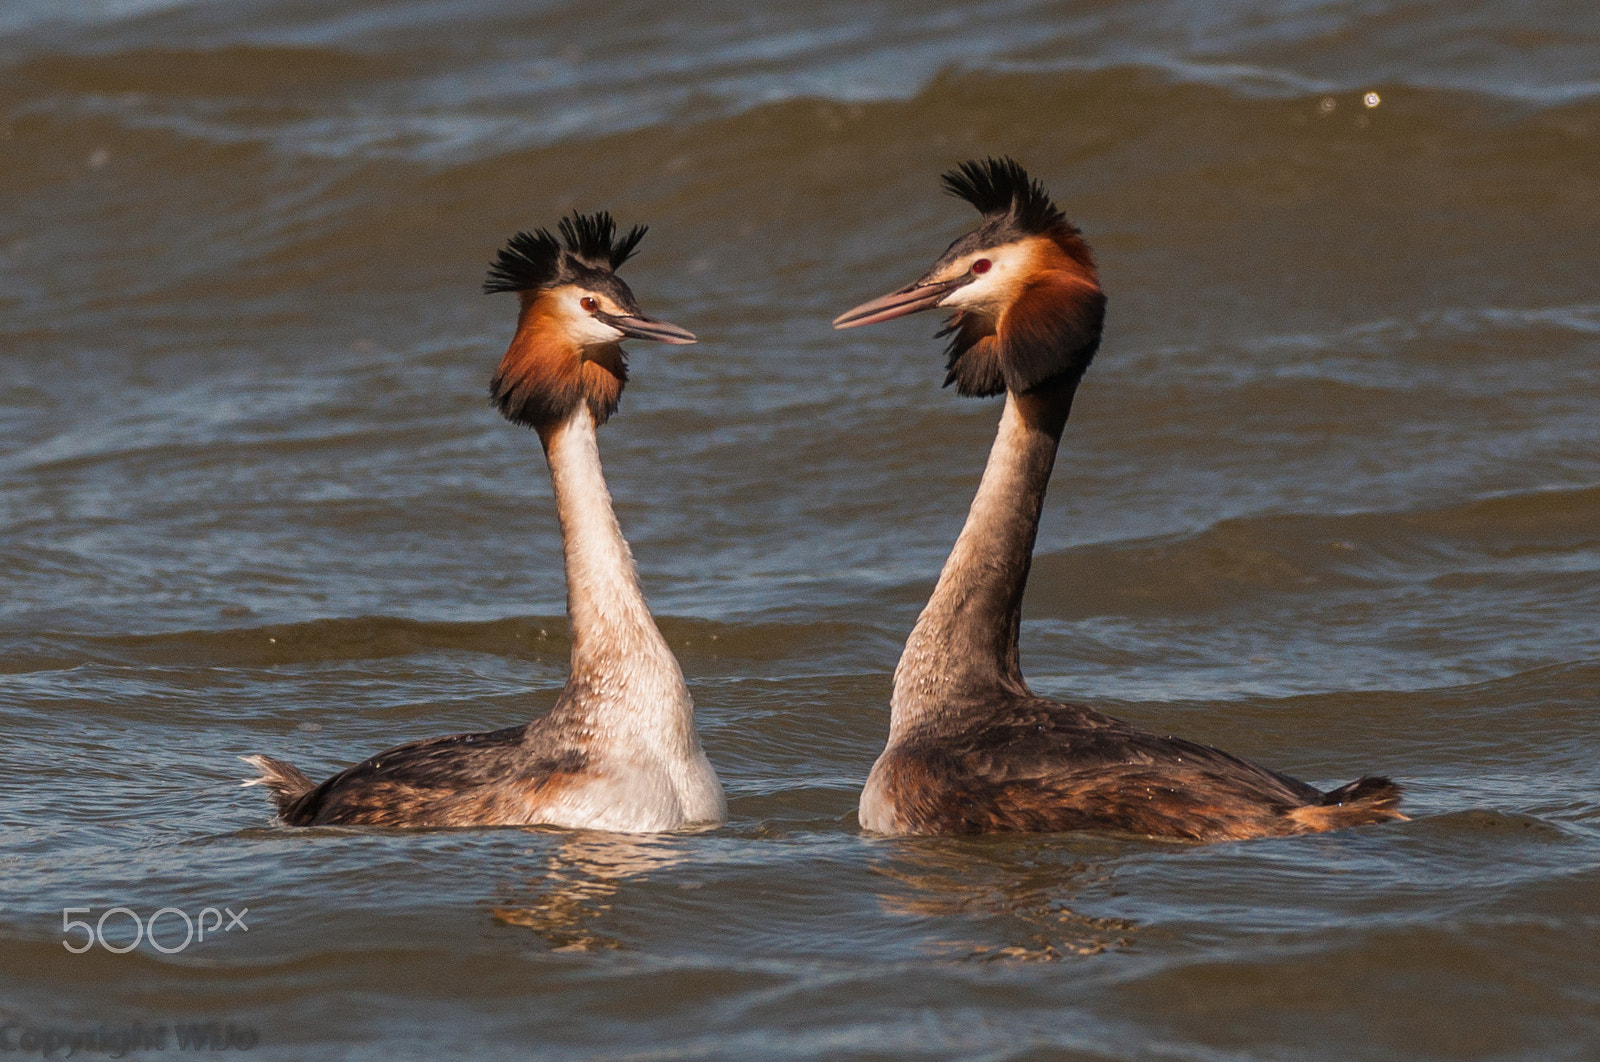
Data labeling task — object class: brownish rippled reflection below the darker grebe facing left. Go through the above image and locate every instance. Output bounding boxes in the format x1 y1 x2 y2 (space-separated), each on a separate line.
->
874 841 1142 963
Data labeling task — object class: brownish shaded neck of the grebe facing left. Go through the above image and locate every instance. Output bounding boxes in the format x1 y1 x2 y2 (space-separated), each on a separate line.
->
890 387 1074 742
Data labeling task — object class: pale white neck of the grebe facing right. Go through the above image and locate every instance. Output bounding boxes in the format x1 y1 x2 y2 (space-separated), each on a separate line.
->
541 403 699 752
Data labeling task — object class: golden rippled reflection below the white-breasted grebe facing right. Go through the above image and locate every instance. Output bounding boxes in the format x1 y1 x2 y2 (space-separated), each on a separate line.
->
490 830 683 952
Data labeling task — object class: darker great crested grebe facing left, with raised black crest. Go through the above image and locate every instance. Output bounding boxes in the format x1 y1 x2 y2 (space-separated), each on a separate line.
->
834 158 1405 841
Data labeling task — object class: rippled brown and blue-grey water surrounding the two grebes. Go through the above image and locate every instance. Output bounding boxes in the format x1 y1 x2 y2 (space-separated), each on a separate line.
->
0 0 1600 1062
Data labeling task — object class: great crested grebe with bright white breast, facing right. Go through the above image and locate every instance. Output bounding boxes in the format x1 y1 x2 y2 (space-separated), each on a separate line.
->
245 213 726 833
